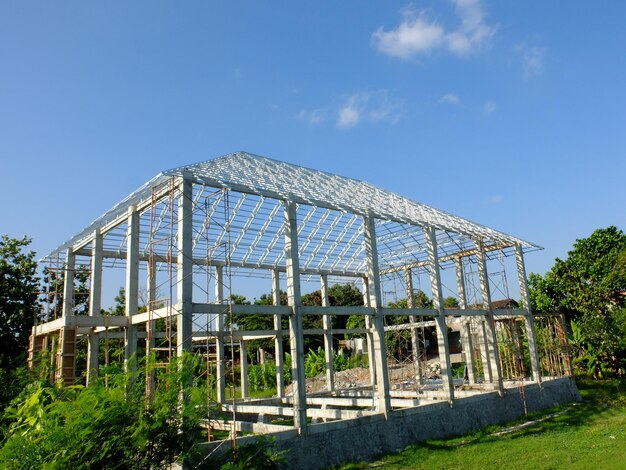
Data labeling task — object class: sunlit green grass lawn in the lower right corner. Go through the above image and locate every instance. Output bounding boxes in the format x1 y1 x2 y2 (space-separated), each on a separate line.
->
341 380 626 470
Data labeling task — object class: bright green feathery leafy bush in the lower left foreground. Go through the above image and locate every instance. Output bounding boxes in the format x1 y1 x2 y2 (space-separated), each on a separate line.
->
0 356 207 469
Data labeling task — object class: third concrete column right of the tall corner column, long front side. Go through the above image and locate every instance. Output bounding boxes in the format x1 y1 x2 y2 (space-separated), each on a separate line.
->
424 226 454 403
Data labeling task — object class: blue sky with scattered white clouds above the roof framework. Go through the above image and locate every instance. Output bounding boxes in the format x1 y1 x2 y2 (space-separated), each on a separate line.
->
0 0 626 304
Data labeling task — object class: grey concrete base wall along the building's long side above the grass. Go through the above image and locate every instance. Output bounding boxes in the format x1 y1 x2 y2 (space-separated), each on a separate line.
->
197 377 580 469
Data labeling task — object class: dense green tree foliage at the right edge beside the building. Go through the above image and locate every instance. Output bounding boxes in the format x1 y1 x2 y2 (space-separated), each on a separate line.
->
529 226 626 377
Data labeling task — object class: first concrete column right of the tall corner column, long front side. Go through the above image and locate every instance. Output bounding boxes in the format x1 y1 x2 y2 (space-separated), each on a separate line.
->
284 201 307 434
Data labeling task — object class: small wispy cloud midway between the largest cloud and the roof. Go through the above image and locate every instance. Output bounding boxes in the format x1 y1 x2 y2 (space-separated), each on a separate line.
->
337 90 401 128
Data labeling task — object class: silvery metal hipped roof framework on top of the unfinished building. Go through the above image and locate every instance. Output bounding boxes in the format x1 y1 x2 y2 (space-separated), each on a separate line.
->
43 152 541 277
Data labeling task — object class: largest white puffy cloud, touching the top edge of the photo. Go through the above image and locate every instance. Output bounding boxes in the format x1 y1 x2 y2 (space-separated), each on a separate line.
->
372 0 496 59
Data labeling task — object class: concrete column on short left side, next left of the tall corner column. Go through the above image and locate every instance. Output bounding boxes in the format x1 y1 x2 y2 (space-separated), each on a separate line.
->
124 205 139 375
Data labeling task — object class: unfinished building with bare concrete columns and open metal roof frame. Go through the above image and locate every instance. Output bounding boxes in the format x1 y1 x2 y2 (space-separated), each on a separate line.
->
30 152 577 468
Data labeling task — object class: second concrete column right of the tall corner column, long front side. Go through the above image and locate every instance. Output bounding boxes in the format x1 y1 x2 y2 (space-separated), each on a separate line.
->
363 215 391 416
